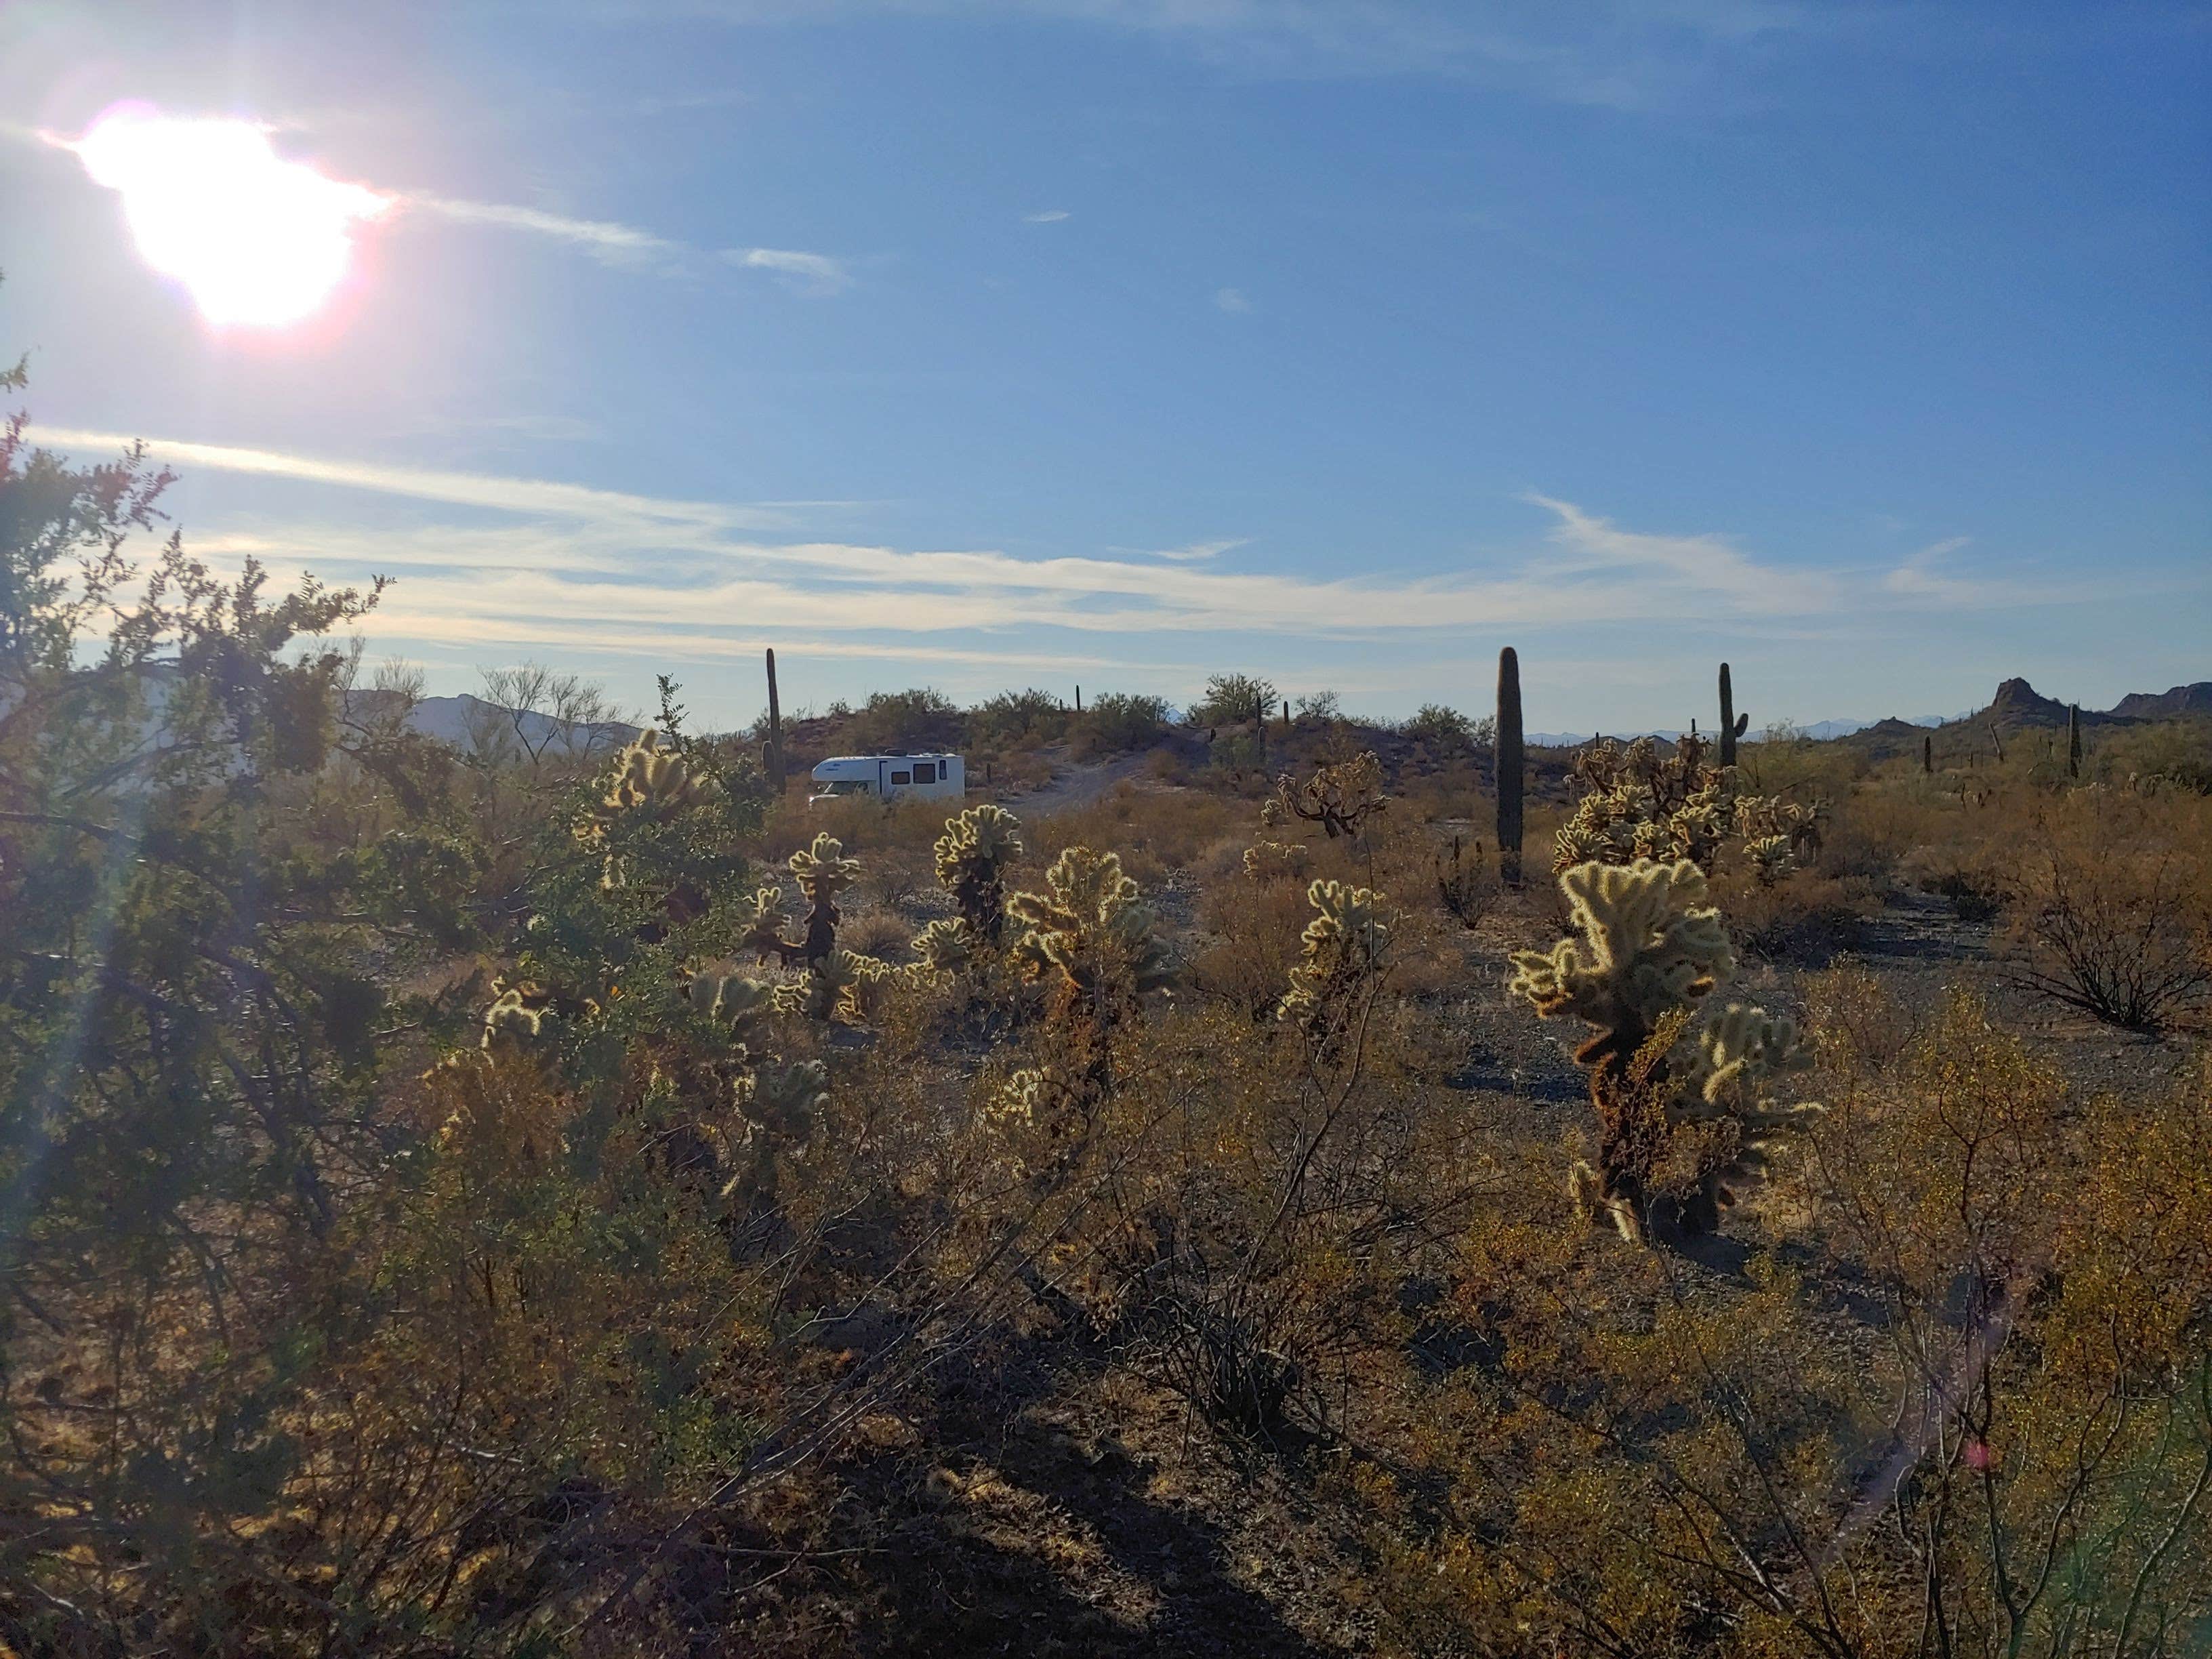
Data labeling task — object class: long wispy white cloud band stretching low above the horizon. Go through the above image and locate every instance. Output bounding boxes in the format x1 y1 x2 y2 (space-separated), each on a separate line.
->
33 429 2079 661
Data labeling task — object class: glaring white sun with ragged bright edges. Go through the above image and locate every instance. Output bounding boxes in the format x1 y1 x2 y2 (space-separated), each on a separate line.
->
68 104 392 327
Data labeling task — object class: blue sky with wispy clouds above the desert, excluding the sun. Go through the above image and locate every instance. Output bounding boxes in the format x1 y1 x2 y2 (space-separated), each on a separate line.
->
0 0 2212 730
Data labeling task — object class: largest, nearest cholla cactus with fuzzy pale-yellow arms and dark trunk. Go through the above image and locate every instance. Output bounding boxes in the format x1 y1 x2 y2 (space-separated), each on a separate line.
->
1507 861 1818 1239
